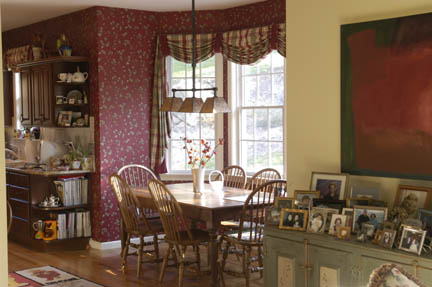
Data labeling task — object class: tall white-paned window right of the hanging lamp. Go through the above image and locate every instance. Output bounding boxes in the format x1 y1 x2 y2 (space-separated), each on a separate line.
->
231 51 285 173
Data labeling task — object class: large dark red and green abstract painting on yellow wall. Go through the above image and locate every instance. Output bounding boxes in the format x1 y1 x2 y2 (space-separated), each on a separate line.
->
341 13 432 179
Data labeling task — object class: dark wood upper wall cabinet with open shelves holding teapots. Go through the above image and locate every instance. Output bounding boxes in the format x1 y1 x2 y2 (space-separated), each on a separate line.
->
18 56 90 127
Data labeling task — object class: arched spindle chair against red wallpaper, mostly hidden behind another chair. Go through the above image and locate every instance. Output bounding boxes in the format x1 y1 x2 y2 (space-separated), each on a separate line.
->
117 164 159 220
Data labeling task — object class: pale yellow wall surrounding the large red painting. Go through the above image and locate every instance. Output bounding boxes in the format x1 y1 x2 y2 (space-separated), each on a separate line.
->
285 0 432 207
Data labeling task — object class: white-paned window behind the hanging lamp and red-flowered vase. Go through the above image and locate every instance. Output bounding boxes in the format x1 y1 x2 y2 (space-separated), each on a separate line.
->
167 56 222 173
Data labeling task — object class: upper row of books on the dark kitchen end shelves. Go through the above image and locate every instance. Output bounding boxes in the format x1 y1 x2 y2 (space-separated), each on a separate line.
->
54 176 88 206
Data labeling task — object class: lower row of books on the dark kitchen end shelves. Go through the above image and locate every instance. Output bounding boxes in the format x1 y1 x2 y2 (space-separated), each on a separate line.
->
57 210 91 239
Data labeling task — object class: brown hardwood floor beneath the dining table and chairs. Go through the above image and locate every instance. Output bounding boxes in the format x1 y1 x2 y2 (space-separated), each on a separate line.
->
8 242 264 287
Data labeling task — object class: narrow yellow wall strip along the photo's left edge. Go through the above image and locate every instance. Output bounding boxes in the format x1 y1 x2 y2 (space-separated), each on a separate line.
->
0 9 8 286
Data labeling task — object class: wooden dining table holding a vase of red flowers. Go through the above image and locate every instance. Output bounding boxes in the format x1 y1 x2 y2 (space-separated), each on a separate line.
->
131 183 251 286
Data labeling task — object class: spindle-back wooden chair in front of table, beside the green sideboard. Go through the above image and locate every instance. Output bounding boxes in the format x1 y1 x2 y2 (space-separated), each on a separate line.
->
220 180 286 287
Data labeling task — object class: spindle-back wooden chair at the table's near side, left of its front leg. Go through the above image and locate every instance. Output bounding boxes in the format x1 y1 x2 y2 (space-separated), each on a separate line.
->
149 179 210 287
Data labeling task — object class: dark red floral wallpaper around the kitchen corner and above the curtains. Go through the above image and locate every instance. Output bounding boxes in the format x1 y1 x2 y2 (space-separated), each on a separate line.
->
3 0 285 242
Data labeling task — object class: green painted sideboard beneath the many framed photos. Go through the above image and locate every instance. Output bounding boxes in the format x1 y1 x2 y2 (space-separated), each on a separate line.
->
264 227 432 287
